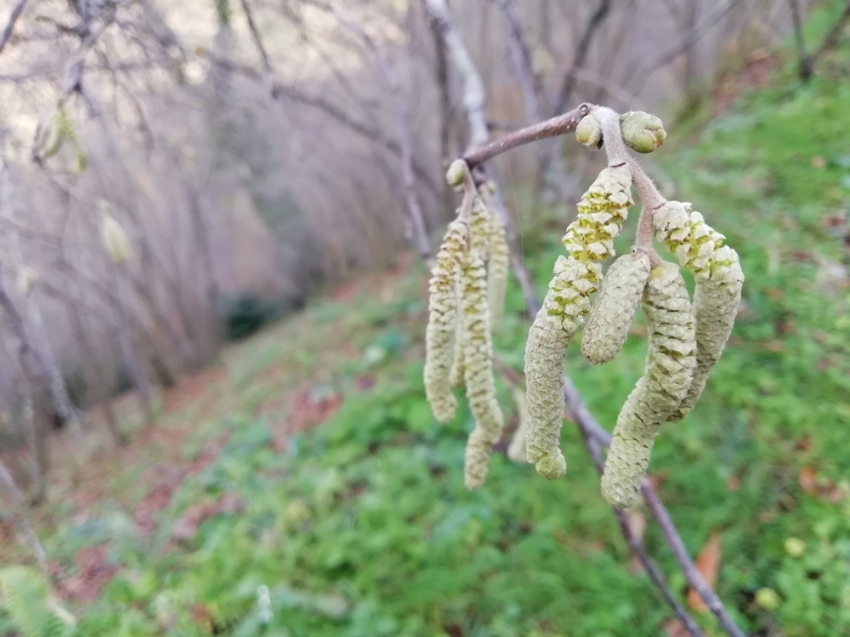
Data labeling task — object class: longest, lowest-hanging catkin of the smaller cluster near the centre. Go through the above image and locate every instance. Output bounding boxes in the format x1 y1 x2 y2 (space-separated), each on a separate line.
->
460 250 504 490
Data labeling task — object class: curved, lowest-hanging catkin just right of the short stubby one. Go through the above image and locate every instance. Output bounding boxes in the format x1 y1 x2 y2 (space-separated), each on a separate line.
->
602 263 696 509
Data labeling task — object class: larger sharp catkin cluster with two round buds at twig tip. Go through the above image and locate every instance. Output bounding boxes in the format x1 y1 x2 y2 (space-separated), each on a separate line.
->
525 109 744 508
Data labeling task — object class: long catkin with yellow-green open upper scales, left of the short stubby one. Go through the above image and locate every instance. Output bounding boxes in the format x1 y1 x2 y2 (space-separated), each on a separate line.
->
525 166 632 479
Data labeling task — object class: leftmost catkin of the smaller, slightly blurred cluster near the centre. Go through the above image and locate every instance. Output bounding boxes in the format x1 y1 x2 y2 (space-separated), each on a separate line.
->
424 219 468 423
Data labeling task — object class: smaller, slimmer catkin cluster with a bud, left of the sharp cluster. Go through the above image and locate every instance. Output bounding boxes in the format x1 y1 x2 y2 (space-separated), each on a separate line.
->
424 171 508 489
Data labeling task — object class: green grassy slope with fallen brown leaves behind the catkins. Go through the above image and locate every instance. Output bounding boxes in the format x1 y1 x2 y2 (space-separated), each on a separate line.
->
0 12 850 637
